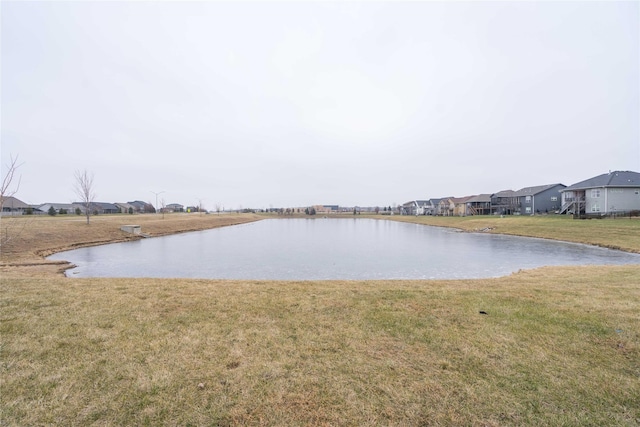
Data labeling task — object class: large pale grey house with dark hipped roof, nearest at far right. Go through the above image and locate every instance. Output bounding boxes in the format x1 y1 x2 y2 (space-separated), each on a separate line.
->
560 171 640 215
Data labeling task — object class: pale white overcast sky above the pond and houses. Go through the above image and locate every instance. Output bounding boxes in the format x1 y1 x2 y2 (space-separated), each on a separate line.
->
0 1 640 209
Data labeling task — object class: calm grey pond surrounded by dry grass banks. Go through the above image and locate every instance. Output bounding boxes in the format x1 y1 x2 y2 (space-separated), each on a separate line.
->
49 218 640 280
